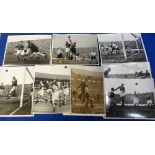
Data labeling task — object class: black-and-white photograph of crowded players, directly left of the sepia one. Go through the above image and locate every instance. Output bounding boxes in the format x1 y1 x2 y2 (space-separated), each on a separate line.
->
32 65 71 114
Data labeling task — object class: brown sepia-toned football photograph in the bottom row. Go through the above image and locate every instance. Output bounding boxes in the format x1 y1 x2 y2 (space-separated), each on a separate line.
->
71 66 105 116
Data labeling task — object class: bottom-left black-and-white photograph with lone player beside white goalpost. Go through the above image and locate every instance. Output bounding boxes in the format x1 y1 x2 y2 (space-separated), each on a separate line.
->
0 66 34 116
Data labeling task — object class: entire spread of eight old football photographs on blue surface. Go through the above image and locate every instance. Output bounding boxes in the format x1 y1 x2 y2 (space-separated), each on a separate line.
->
0 33 155 118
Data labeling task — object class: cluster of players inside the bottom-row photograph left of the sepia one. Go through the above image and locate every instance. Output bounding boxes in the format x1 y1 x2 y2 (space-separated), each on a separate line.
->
35 80 70 112
